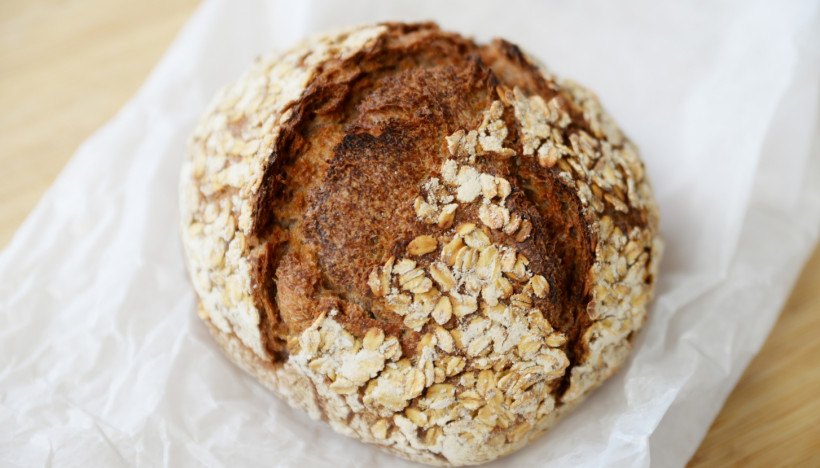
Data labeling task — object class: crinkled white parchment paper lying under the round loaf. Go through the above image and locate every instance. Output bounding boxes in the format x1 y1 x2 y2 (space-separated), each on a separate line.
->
0 0 820 468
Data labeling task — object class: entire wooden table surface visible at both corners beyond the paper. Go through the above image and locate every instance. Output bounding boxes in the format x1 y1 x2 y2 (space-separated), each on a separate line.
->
0 0 820 467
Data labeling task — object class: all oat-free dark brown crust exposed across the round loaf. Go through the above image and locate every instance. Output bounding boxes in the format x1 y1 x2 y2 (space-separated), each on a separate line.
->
247 24 645 370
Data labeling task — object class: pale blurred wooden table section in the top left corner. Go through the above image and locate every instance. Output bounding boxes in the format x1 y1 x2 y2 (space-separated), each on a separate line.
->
0 0 198 247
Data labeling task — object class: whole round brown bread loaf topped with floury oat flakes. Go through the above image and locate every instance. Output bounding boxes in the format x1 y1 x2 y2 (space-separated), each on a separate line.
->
181 23 660 465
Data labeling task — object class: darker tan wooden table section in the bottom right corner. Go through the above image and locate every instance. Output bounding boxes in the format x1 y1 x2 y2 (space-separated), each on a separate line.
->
690 249 820 468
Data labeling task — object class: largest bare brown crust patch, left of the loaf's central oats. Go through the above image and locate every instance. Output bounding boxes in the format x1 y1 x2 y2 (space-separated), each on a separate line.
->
254 24 494 358
